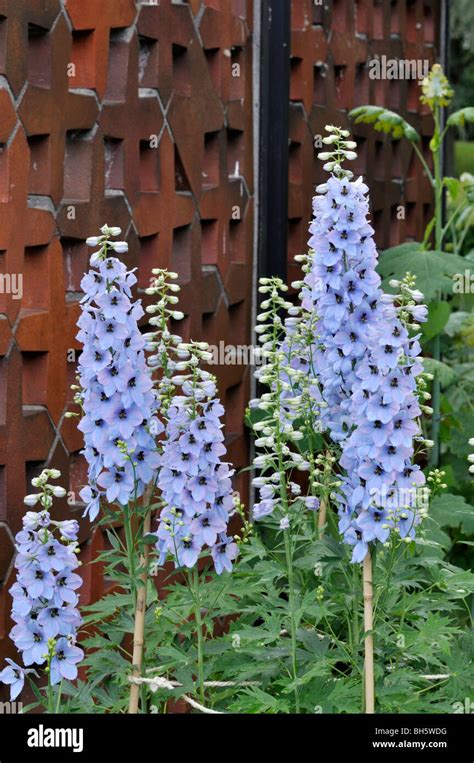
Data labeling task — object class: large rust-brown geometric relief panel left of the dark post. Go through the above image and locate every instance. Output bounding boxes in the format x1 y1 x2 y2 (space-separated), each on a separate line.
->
0 0 253 655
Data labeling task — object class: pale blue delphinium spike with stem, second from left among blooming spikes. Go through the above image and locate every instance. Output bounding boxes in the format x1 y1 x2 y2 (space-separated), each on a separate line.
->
156 342 238 700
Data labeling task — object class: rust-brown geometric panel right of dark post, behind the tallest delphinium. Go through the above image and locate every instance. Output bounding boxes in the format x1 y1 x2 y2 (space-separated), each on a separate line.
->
288 0 440 286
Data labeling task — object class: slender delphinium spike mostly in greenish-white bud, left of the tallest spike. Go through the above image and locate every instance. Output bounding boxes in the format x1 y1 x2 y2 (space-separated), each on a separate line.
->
250 278 319 712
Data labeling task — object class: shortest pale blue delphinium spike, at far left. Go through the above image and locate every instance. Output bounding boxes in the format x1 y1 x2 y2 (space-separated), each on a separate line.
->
0 469 84 713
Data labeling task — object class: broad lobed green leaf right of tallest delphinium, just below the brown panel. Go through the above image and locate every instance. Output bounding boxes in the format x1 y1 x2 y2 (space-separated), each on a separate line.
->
377 242 465 302
